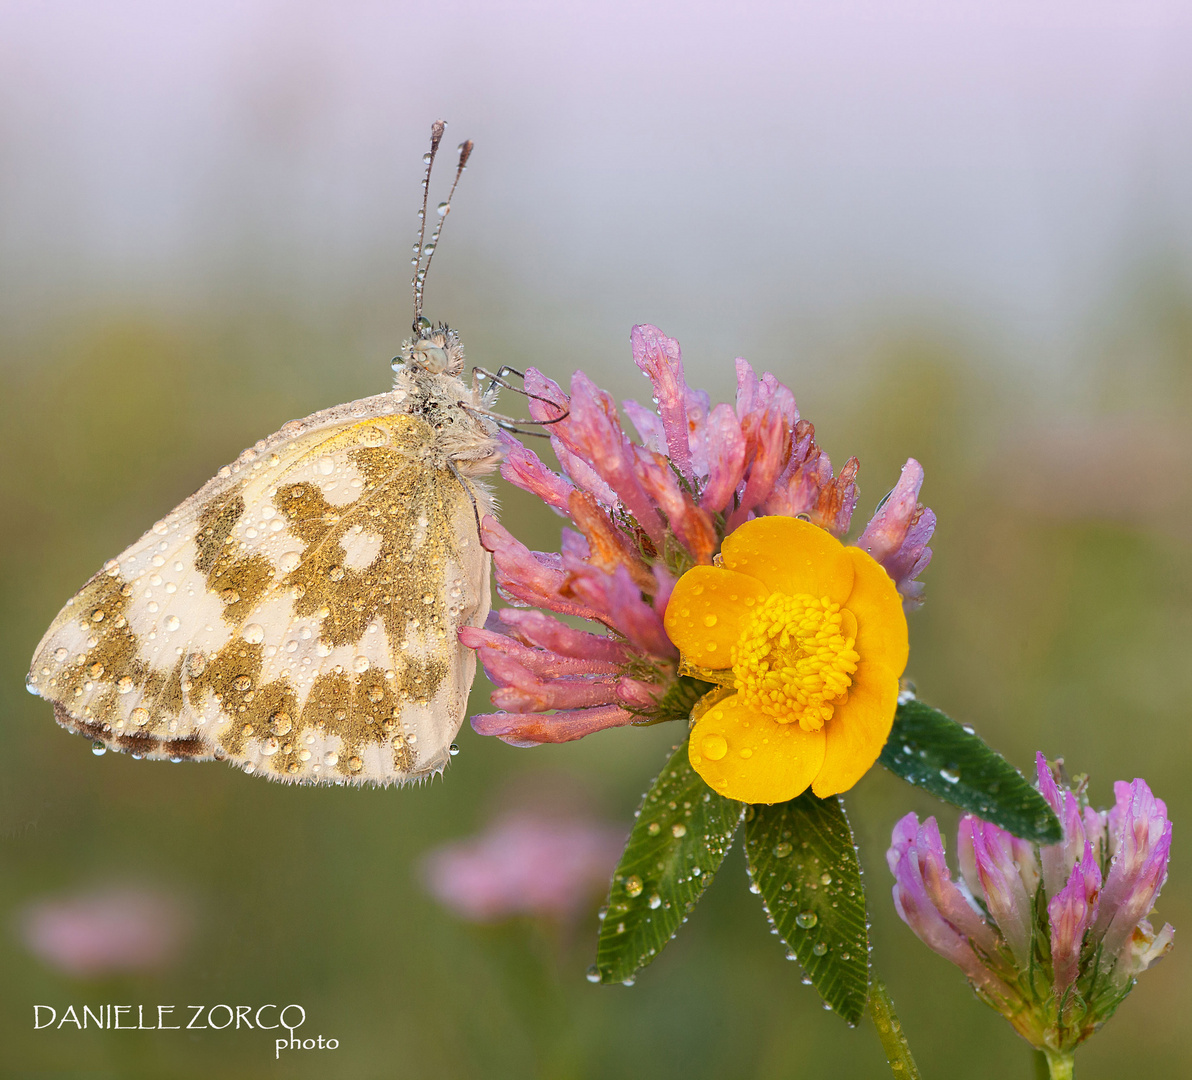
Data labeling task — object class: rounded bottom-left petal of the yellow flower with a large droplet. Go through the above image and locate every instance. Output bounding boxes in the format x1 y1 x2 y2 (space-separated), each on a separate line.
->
688 694 824 802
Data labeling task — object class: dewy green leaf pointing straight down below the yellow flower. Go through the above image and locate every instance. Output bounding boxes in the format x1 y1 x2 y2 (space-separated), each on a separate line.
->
745 792 869 1024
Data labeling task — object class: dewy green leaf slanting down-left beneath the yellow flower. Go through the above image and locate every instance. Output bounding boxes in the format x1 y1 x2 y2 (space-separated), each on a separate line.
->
596 739 745 982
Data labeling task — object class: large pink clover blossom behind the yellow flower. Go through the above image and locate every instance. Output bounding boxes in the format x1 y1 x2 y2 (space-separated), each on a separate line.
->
460 325 935 746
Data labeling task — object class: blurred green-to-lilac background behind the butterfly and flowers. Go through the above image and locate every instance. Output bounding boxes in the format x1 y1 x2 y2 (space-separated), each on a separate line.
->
0 0 1192 1080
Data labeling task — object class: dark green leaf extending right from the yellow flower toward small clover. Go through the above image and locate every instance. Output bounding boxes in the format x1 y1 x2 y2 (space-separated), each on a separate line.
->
879 700 1062 844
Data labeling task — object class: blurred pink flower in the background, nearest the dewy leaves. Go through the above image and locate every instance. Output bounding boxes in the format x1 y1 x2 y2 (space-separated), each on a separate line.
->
422 809 626 923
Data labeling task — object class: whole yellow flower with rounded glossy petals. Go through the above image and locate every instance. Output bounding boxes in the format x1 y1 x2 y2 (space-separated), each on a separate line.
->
665 517 908 802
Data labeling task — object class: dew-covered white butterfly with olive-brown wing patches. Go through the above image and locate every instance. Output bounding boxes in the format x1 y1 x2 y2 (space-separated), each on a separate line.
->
27 120 507 784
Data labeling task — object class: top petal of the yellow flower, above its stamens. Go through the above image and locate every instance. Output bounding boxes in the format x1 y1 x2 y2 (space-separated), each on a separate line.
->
724 517 852 603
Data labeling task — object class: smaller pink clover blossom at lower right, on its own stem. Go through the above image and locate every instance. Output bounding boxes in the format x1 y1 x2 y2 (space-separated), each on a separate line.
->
887 753 1174 1055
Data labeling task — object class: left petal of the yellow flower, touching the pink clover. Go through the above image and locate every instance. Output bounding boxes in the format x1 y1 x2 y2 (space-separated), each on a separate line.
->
663 566 769 668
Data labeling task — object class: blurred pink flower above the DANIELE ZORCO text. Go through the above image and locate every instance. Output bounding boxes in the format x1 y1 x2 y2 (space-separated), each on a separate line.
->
17 886 191 979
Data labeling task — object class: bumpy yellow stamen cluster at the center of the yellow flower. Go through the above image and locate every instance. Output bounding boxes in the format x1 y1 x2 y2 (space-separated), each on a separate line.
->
732 592 861 731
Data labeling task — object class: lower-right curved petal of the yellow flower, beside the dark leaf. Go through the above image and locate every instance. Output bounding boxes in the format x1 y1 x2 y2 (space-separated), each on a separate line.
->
812 653 901 799
